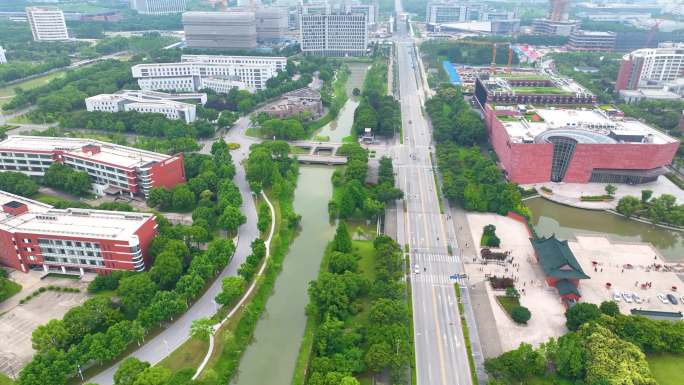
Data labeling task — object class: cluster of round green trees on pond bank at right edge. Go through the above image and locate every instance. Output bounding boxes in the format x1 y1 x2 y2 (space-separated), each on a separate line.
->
617 194 684 226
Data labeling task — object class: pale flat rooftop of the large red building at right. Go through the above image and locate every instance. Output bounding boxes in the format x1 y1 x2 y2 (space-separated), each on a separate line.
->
495 106 677 144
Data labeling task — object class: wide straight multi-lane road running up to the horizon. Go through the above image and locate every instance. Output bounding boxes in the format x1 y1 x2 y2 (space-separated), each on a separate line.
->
395 0 472 385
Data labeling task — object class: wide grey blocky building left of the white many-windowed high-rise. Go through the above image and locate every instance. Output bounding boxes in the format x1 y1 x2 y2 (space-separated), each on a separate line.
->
183 10 257 50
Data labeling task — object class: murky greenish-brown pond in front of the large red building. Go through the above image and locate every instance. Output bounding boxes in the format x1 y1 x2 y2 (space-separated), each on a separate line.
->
525 198 684 261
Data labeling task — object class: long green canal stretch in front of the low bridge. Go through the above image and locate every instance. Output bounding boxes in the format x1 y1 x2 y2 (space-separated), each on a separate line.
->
233 166 334 385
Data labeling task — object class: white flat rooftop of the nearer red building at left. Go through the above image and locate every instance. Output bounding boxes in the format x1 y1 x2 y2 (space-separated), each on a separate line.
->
0 190 153 240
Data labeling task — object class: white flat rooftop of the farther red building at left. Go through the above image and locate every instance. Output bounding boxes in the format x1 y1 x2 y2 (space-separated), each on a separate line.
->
0 135 170 169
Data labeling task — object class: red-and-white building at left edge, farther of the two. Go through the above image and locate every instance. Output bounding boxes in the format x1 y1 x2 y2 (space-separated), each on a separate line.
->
0 135 185 196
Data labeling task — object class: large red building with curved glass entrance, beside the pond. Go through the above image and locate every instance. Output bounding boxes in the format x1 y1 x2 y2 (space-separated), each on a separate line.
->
484 104 679 184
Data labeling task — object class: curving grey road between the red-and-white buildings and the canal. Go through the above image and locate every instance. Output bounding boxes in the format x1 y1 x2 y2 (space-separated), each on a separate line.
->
88 117 259 385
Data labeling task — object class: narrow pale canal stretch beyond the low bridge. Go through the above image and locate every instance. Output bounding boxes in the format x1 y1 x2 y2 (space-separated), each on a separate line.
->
316 62 370 142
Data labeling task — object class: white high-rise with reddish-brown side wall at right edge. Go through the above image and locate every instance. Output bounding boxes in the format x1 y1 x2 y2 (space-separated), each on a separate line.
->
615 43 684 91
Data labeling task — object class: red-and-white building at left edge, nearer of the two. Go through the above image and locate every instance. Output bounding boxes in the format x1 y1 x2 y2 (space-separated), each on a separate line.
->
0 191 157 275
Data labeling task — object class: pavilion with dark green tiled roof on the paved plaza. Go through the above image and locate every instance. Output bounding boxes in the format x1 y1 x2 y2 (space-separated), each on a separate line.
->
530 234 590 301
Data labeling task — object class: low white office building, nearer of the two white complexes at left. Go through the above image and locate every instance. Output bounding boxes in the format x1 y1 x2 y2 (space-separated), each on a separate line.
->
85 90 207 123
